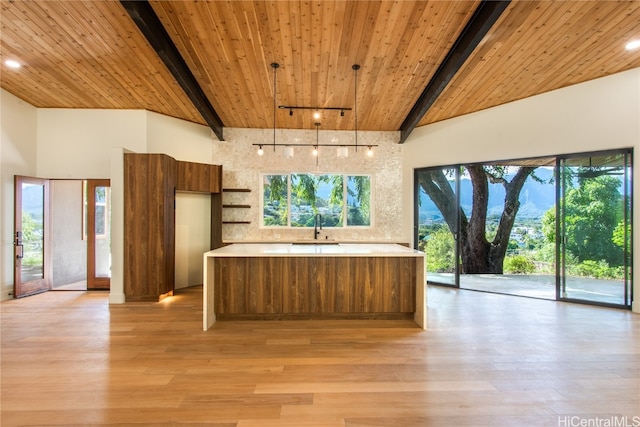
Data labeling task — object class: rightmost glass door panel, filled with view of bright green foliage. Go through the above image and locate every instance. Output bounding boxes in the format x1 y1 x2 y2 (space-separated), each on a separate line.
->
557 152 632 307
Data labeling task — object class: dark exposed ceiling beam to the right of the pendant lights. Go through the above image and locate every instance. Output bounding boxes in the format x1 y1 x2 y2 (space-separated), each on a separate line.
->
400 0 511 144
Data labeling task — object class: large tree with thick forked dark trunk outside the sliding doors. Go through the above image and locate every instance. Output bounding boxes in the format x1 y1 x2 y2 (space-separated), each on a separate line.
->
419 165 536 274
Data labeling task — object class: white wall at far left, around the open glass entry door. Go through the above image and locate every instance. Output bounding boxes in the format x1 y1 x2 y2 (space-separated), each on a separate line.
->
0 89 38 300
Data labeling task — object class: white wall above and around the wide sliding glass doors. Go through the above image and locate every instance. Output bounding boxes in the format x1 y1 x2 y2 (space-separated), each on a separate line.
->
402 69 640 312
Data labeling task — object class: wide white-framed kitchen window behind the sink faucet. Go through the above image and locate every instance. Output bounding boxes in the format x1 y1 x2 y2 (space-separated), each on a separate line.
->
262 173 371 228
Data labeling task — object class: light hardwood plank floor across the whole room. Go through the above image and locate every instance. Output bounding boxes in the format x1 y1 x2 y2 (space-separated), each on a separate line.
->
0 287 640 427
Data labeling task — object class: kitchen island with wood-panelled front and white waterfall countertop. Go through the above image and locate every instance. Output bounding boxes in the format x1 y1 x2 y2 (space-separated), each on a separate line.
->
203 241 427 330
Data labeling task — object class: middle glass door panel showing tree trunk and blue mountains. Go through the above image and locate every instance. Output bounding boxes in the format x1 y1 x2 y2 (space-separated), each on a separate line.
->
459 162 556 299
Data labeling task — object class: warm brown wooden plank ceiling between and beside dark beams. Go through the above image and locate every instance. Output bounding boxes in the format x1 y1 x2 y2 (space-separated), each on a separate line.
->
0 0 640 140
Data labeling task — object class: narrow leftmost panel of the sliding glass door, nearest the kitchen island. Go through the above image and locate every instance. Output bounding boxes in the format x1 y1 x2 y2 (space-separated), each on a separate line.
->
415 168 460 287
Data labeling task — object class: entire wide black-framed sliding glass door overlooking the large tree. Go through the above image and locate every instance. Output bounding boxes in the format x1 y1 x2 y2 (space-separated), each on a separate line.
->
414 150 633 307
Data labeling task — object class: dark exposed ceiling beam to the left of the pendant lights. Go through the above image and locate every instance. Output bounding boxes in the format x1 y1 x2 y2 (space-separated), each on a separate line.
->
120 0 223 141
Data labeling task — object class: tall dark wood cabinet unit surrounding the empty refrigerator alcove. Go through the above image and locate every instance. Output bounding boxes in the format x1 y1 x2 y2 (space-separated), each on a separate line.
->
123 153 222 301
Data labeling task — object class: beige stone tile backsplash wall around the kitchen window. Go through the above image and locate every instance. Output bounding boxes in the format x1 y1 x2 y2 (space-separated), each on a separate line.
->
212 128 404 242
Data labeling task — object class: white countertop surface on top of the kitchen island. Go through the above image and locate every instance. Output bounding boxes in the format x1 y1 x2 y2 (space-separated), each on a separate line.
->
204 241 424 258
